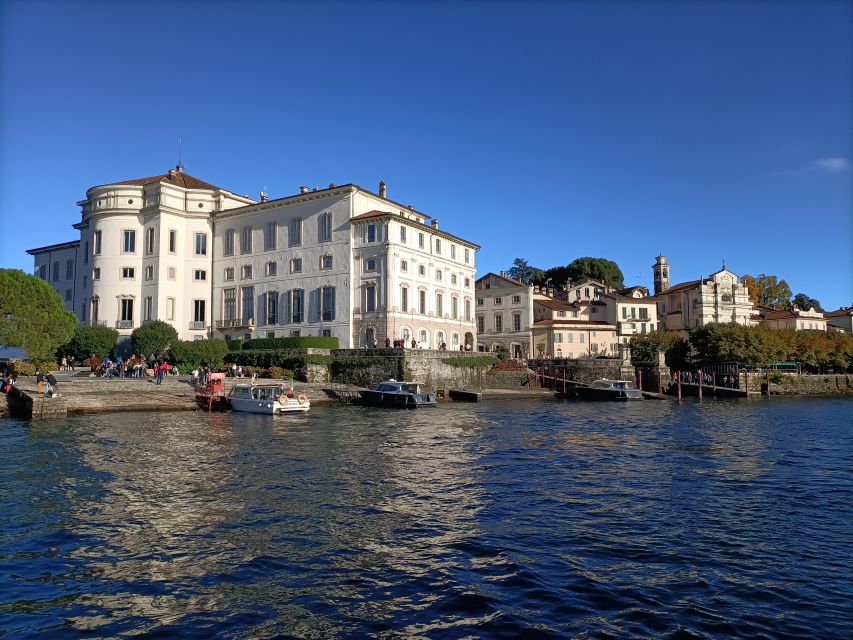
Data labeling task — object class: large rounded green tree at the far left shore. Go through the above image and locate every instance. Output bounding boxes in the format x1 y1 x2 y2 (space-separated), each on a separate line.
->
0 269 77 360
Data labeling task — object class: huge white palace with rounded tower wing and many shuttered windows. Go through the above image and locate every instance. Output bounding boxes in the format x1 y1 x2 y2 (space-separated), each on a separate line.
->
27 165 480 350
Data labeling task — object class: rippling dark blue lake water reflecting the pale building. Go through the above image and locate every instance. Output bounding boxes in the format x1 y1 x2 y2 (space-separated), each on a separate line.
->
0 398 853 639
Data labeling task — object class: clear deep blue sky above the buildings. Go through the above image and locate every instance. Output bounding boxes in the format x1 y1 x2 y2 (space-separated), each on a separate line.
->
0 0 853 308
